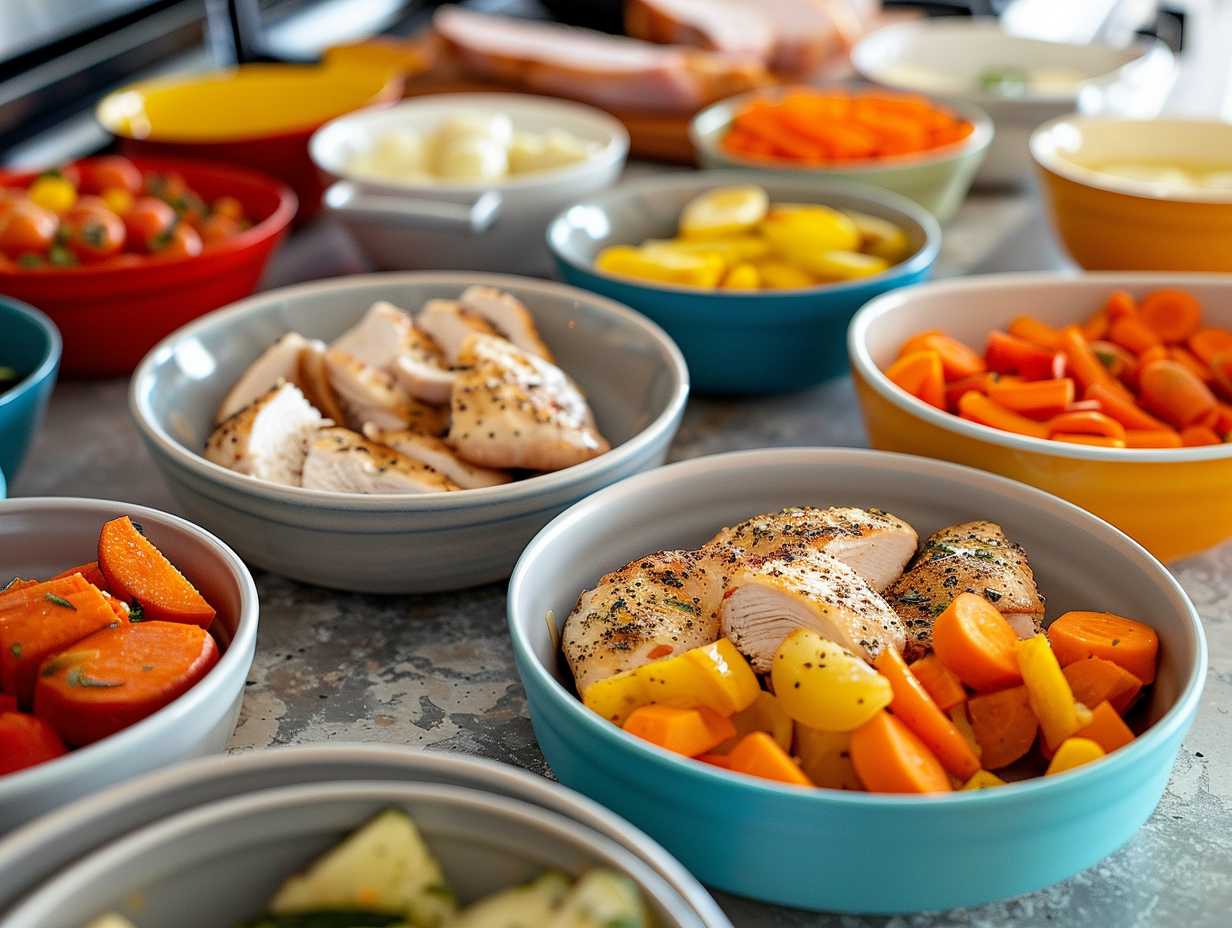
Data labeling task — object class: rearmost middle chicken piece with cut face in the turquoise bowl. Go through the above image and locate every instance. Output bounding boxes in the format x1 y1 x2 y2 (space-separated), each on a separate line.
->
708 507 919 593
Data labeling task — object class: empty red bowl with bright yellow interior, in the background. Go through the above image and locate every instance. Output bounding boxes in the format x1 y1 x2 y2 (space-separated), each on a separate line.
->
96 64 402 219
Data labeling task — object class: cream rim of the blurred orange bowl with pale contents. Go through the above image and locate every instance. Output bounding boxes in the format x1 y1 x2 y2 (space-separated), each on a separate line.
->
1027 113 1232 206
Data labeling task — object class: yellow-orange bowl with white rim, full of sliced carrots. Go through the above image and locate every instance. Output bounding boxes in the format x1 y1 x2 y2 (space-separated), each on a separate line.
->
848 274 1232 561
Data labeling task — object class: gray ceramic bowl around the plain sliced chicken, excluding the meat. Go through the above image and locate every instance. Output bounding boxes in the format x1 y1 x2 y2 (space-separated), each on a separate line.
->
129 272 689 593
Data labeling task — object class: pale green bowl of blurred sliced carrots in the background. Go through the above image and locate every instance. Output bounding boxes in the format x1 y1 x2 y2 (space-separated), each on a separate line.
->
689 86 993 222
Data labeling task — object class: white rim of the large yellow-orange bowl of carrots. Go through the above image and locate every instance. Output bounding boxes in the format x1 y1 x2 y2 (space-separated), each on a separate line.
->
848 271 1232 463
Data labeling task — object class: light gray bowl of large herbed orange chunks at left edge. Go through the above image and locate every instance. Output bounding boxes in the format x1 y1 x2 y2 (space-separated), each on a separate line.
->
0 498 257 833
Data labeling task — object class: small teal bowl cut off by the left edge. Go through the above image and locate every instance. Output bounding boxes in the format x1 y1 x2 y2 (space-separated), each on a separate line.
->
0 297 60 485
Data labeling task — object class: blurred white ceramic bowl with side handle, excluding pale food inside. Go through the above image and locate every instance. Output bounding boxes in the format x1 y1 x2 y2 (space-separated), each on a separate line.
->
309 94 628 274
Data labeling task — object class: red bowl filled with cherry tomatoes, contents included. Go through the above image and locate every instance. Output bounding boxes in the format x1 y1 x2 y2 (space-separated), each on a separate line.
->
0 155 297 377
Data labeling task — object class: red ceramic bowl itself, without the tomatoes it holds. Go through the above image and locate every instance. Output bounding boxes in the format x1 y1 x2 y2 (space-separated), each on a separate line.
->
0 159 296 377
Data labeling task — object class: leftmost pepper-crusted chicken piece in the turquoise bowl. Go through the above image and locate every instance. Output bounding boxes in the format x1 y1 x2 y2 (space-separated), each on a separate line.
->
561 551 723 693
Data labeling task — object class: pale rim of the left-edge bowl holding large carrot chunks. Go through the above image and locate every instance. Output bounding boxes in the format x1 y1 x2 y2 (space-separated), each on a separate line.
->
0 497 260 801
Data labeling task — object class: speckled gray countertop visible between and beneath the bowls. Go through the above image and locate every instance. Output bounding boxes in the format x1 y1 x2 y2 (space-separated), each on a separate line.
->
11 200 1232 928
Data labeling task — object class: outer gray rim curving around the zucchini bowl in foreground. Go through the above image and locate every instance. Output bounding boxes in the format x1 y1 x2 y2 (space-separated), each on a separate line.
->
0 743 731 928
